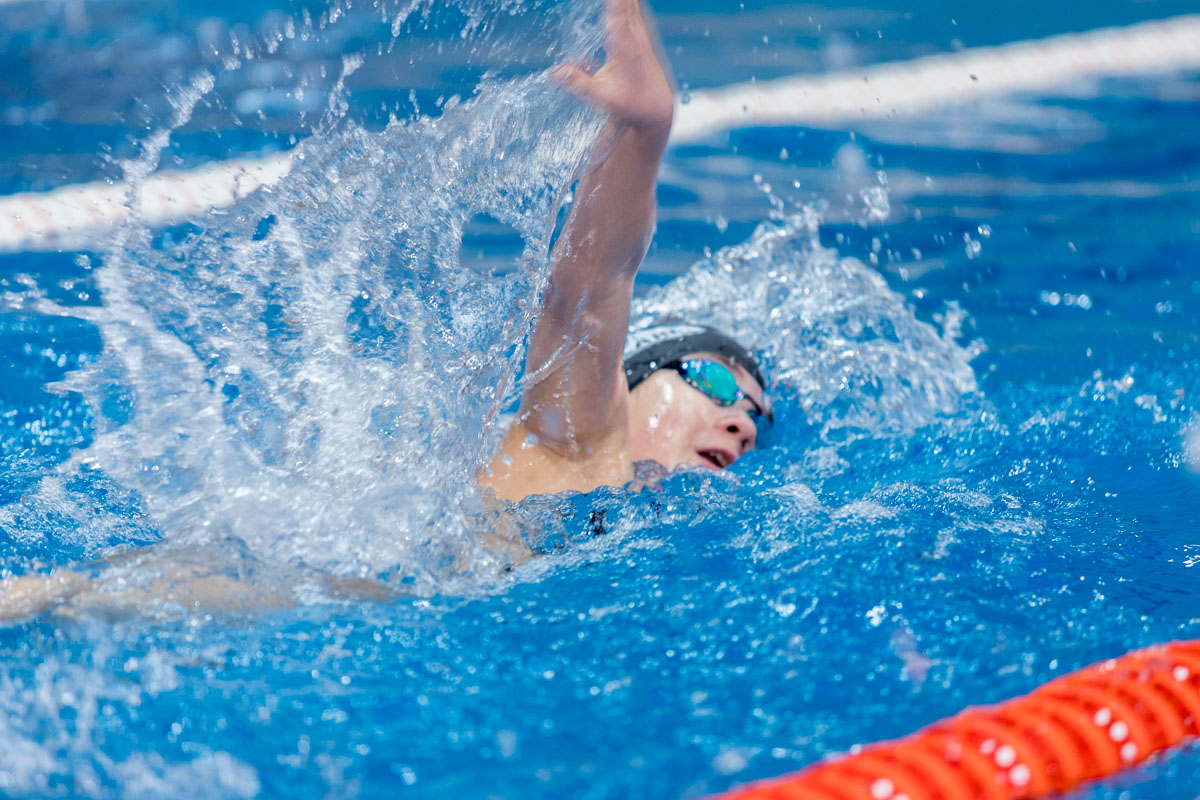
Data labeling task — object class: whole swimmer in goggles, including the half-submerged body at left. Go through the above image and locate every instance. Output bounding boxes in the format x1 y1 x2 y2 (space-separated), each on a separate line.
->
0 0 770 621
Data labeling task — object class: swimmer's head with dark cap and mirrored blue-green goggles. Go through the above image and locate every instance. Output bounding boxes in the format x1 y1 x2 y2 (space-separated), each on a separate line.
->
624 324 770 469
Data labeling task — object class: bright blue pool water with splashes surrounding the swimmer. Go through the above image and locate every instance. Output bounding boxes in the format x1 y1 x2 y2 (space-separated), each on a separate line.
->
0 0 1200 799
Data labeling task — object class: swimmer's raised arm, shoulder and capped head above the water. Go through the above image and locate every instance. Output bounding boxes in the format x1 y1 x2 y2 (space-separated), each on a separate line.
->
478 0 770 501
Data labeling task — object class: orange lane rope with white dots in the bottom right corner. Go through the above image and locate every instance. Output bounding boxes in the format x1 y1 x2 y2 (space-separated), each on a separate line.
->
712 640 1200 800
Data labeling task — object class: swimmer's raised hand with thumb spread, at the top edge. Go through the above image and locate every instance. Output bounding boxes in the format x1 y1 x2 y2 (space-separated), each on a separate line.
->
550 0 674 136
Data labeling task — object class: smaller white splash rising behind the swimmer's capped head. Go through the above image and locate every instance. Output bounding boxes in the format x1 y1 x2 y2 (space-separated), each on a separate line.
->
634 209 982 443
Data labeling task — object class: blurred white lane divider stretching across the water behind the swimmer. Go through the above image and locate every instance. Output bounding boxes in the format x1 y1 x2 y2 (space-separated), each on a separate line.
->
0 13 1200 252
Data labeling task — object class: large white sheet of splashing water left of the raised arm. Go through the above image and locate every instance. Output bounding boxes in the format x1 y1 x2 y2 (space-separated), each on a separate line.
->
4 4 609 591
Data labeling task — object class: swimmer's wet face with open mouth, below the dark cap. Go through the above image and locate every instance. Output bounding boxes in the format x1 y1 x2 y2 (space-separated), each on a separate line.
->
629 353 766 469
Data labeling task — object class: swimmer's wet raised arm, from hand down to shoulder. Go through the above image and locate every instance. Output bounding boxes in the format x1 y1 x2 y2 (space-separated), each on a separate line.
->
484 0 674 494
